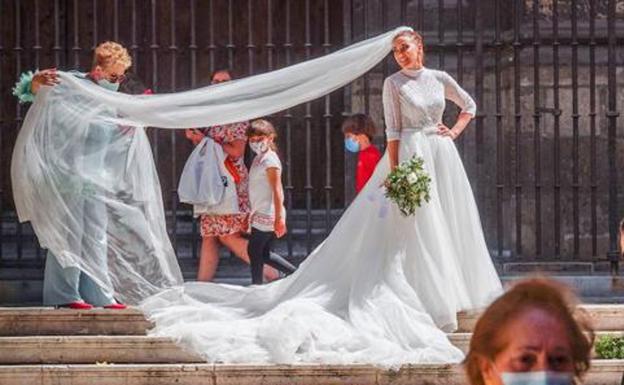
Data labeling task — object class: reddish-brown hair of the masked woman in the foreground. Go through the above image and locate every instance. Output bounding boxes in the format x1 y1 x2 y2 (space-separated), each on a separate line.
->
464 278 594 385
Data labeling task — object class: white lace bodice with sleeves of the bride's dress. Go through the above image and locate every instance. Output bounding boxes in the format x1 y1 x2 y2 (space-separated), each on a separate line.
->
383 67 477 141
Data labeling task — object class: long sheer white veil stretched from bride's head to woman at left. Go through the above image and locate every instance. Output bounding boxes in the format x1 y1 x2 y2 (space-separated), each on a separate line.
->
11 27 409 304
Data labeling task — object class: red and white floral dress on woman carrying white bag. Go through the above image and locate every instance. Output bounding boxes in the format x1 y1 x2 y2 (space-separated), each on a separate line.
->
200 122 250 237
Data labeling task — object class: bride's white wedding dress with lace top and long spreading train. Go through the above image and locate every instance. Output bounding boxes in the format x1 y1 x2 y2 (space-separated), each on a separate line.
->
142 69 501 366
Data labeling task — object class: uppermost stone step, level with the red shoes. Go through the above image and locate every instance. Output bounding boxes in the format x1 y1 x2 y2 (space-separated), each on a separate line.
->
0 304 624 336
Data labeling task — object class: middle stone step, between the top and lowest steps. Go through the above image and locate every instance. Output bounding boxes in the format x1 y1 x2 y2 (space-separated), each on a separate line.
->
0 332 624 365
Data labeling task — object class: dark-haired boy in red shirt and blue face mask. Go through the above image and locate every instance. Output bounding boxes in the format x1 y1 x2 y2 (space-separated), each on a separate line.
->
342 114 381 193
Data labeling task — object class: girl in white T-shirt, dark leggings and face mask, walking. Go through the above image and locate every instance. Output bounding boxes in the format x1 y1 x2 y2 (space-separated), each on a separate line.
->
247 119 295 285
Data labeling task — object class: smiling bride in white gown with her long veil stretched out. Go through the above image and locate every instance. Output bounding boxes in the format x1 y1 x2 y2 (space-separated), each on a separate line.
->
11 27 501 366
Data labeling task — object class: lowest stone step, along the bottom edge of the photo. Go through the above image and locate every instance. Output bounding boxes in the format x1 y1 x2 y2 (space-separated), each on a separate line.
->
0 360 624 385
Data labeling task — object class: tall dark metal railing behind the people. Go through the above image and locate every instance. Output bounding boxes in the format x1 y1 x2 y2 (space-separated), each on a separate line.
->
0 0 624 266
